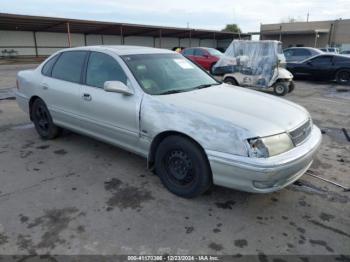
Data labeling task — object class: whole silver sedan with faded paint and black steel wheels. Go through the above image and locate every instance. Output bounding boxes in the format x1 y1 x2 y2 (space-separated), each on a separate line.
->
16 46 321 197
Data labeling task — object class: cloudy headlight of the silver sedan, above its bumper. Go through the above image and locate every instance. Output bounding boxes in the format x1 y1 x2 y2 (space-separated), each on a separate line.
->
248 133 294 157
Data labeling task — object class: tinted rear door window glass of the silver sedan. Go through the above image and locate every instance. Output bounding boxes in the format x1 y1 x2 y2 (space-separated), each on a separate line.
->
52 51 86 83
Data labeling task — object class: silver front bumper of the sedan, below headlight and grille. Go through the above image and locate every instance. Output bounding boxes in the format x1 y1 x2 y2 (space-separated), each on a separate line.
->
206 125 322 193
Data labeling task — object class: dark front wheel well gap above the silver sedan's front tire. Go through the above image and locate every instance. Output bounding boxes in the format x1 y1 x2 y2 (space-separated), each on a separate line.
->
147 131 211 170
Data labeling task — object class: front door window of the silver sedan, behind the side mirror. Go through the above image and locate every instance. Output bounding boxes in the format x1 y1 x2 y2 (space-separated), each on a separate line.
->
86 52 127 88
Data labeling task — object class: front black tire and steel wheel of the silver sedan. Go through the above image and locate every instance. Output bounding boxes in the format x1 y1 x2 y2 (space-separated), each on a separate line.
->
155 136 212 198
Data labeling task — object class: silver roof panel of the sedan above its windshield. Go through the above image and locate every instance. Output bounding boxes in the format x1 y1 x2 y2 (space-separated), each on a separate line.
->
62 45 175 55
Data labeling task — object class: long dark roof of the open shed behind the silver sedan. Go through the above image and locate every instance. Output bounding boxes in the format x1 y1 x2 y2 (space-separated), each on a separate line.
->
0 13 250 40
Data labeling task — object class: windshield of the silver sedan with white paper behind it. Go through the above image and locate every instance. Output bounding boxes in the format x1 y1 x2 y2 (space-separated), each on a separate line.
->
122 54 219 95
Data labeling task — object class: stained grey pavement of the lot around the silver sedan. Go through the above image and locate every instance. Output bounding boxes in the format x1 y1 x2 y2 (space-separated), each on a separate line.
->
0 64 350 256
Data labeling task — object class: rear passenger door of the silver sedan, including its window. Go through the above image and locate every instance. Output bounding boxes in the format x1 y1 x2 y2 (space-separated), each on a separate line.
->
40 51 87 127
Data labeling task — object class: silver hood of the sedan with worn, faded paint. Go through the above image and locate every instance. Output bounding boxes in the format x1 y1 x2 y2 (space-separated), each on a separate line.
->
156 84 310 137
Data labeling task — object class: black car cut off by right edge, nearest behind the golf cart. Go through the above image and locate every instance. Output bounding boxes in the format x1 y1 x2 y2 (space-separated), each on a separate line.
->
287 53 350 84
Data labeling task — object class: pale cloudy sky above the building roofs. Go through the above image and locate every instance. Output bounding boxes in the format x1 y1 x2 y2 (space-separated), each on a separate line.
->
0 0 350 32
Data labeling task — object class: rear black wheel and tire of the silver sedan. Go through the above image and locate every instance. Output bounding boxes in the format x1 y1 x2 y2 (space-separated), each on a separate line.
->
30 98 61 140
